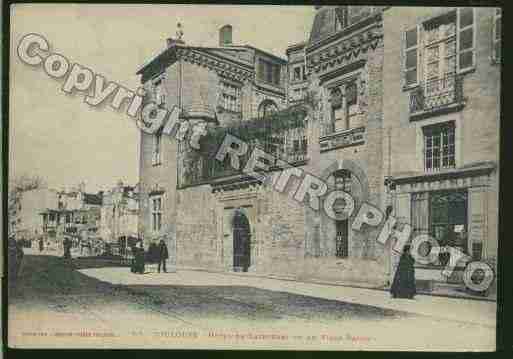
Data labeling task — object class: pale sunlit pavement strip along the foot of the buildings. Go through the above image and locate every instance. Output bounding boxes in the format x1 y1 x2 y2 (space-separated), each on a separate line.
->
80 268 497 328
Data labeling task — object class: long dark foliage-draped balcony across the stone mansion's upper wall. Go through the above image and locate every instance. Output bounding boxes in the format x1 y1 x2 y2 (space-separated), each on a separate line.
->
179 105 307 188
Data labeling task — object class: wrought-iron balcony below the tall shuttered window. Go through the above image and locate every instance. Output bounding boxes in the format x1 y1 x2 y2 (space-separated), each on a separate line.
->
410 74 465 121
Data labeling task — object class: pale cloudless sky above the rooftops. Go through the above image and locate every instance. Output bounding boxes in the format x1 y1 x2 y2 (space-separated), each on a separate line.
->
9 4 315 192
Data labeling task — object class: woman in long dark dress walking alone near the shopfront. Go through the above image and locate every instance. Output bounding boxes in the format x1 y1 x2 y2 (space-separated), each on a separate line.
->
390 245 417 299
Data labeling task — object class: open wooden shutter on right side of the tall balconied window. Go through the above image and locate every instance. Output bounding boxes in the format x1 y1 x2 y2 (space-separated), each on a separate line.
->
456 7 476 71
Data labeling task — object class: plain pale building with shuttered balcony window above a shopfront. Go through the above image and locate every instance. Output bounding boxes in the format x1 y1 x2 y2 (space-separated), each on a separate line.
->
382 7 501 290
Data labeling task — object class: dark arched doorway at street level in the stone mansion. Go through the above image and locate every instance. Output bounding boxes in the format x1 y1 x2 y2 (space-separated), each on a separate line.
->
233 212 251 272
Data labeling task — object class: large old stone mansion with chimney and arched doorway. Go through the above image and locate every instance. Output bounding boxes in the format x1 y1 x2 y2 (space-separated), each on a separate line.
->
138 6 384 283
